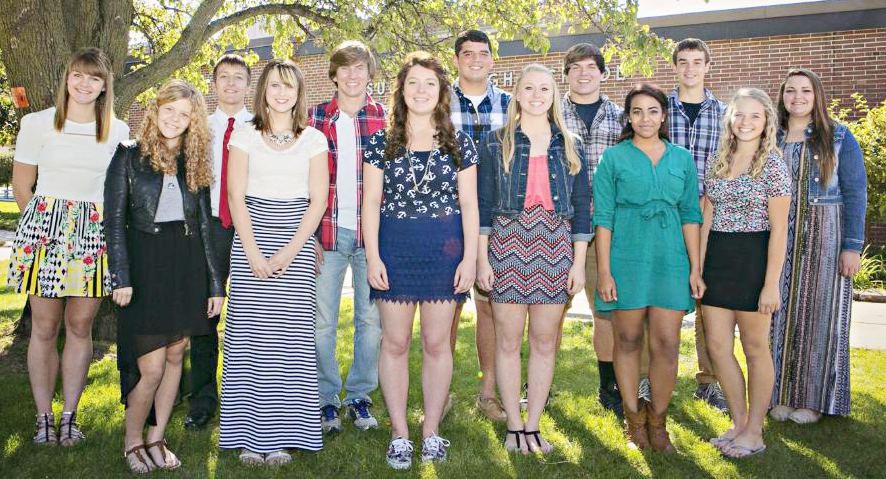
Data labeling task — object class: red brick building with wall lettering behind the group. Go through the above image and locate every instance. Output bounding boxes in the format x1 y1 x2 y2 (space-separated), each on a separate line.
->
128 0 886 244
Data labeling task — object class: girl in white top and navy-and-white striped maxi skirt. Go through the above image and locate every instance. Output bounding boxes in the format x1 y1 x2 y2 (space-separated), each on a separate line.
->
219 60 329 464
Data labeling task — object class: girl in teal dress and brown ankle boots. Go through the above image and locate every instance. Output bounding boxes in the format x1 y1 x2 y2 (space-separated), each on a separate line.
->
593 84 704 452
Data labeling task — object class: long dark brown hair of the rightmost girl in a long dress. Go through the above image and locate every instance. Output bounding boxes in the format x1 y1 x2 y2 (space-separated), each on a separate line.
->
778 68 836 185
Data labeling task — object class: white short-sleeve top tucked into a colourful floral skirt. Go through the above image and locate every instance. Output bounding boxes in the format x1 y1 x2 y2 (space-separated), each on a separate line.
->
15 107 129 204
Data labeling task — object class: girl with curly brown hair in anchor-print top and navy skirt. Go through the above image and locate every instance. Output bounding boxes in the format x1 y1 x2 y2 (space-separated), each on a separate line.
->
363 52 479 469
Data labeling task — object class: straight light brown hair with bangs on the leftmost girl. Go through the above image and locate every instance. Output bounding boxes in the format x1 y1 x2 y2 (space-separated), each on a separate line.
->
53 47 114 143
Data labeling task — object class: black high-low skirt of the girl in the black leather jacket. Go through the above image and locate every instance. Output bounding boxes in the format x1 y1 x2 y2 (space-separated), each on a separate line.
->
117 221 212 416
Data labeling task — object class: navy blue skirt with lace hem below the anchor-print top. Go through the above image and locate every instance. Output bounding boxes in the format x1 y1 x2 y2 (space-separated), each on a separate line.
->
369 214 468 303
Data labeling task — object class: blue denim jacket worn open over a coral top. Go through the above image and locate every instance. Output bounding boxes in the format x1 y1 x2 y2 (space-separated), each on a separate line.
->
478 123 594 241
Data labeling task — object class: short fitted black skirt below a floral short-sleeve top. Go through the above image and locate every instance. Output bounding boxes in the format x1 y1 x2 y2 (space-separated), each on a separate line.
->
701 231 769 311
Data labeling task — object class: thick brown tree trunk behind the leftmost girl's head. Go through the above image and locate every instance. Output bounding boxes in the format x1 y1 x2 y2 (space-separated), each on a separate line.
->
0 0 133 115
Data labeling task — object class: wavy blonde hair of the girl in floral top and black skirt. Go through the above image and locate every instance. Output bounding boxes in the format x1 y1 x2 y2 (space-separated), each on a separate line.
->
713 88 781 178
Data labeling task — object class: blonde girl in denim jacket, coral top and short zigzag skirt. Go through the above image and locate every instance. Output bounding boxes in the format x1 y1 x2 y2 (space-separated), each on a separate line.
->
477 65 592 454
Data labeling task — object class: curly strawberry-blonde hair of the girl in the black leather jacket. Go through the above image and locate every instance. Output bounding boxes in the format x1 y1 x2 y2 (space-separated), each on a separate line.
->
135 80 212 191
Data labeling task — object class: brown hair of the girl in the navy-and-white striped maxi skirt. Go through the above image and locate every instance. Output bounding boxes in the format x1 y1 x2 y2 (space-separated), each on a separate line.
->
252 60 308 137
